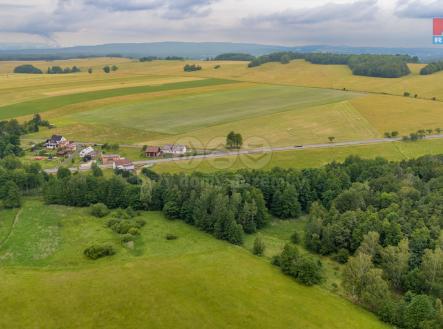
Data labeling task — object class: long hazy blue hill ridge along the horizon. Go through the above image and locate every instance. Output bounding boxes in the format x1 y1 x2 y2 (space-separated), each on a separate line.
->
0 42 443 62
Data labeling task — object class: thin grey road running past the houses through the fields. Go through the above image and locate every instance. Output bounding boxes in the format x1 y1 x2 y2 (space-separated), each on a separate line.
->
45 134 443 174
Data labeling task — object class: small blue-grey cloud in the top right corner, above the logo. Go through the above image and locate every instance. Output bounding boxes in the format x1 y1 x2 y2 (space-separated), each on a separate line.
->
395 0 443 18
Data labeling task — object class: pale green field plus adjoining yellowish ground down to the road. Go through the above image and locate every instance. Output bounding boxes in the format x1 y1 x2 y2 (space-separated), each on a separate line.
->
25 80 360 146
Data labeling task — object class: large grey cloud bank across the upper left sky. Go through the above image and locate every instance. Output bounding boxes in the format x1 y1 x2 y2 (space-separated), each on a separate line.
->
0 0 219 39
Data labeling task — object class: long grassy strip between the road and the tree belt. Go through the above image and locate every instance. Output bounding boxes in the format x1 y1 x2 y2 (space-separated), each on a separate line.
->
153 140 443 172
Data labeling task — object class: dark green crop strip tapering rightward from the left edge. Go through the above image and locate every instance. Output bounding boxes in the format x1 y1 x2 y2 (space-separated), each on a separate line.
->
0 79 236 119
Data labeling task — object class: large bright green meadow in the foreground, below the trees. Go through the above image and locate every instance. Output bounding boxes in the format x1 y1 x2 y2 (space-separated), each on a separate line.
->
0 200 388 329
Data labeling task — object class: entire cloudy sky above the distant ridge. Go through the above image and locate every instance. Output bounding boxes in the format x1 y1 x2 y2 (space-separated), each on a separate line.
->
0 0 443 47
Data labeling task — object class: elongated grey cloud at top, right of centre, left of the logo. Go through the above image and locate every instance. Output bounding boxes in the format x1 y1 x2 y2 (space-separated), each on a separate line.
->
244 0 378 25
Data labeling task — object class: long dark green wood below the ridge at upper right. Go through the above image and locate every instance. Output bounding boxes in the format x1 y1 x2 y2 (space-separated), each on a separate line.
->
249 52 418 78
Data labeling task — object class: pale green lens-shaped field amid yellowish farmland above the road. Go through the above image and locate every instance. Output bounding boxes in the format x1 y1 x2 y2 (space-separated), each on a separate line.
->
64 85 358 134
